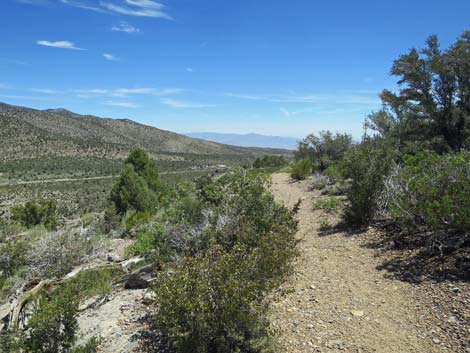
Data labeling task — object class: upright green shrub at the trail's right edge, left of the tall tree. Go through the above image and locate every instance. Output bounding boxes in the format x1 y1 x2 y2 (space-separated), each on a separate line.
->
341 140 393 224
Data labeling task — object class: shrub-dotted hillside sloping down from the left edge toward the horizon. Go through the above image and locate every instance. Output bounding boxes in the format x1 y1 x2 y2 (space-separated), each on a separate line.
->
0 103 286 160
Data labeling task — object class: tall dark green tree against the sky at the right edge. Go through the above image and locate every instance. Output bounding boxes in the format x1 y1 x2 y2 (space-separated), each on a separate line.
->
367 31 470 153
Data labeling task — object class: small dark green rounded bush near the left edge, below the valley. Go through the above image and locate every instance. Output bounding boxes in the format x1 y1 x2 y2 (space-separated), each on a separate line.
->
12 200 58 230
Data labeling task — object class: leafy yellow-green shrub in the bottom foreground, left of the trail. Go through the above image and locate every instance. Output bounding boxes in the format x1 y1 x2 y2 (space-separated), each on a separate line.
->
154 241 290 353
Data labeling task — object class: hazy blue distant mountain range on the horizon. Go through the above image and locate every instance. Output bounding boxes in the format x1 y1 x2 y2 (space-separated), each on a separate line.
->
185 132 298 150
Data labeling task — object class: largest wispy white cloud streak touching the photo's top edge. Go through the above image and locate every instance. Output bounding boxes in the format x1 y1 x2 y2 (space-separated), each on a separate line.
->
100 0 173 20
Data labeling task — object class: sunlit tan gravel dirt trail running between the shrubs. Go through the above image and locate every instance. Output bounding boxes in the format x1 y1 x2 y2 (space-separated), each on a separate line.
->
272 174 443 353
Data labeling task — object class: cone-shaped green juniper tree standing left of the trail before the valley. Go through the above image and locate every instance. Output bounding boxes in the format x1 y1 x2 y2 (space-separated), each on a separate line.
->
110 149 161 215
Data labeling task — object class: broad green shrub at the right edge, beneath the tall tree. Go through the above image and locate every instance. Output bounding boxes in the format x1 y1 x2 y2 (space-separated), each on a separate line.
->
390 151 470 232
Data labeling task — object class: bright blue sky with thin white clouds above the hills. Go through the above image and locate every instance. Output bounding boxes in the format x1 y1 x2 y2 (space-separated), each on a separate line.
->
0 0 470 137
